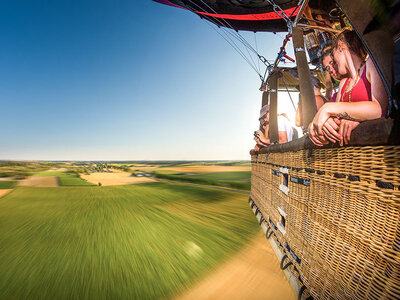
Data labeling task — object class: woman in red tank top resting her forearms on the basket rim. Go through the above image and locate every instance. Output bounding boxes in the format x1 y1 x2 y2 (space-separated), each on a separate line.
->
308 30 388 146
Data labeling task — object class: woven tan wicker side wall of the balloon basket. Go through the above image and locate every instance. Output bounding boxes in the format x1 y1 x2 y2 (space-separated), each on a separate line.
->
251 146 400 299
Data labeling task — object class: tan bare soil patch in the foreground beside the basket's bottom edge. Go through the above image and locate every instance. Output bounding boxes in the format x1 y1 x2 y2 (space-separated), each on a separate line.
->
175 230 296 300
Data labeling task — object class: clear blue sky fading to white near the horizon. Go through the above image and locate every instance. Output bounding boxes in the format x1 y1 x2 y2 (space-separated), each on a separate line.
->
0 0 293 160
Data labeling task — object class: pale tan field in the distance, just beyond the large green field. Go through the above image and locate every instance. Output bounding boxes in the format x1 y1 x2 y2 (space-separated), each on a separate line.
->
81 170 154 185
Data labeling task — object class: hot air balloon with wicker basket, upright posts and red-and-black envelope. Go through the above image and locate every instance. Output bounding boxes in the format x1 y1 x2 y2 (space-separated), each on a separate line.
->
155 0 400 299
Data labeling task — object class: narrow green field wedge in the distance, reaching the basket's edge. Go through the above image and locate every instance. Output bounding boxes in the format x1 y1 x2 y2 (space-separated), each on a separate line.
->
155 171 251 190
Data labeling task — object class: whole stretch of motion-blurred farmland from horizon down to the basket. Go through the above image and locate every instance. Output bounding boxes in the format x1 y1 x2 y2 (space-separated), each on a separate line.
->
0 162 293 299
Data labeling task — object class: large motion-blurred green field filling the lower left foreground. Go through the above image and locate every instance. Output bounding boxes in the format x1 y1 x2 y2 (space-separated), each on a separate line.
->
0 183 258 299
